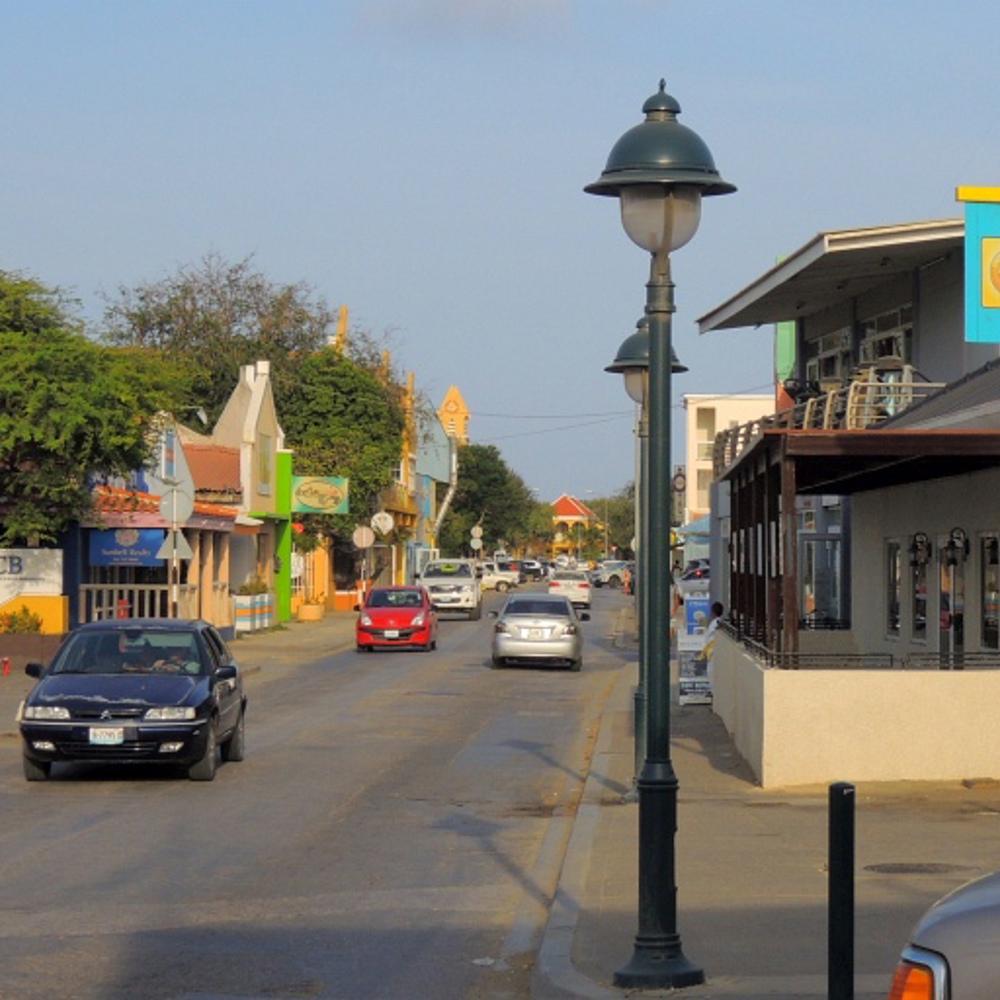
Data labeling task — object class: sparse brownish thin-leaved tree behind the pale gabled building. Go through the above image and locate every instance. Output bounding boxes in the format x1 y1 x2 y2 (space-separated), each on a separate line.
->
104 254 333 423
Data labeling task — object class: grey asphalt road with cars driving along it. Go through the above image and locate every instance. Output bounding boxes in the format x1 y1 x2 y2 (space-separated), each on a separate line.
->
0 591 622 1000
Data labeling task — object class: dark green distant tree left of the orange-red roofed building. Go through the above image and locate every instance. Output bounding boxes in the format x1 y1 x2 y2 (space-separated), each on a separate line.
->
439 444 536 555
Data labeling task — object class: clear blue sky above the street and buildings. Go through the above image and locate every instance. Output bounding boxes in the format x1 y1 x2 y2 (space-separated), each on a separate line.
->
0 0 1000 500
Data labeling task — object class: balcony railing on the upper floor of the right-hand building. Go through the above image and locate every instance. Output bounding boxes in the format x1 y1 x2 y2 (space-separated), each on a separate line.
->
712 368 946 479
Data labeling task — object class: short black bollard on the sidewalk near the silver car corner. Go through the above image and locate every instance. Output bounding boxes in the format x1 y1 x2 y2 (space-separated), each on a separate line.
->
827 781 854 1000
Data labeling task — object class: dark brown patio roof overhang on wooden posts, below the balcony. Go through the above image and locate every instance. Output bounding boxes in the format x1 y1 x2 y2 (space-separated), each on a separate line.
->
721 430 1000 496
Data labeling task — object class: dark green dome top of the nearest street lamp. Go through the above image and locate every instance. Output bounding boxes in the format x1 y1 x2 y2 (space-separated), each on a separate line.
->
584 80 736 196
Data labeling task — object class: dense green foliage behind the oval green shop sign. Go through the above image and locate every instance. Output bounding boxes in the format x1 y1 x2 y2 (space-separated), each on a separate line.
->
275 348 405 536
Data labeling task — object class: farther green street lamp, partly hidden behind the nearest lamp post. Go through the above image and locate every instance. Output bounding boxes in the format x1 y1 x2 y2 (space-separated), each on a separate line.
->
604 316 688 799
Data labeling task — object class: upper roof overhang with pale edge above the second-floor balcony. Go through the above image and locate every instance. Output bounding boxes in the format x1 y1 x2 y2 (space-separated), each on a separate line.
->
698 219 965 333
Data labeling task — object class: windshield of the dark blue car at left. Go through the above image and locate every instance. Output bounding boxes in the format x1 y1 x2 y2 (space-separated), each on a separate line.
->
51 628 203 674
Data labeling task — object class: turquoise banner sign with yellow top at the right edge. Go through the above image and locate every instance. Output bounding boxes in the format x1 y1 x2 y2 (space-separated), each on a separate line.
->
956 187 1000 344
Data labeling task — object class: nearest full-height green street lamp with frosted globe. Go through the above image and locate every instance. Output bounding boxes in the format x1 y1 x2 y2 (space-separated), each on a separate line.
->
585 80 736 989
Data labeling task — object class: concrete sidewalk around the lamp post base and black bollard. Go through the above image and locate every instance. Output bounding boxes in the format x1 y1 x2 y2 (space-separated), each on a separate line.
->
532 604 1000 1000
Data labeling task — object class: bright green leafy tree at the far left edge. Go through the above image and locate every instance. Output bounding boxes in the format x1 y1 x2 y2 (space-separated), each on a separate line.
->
0 271 180 545
